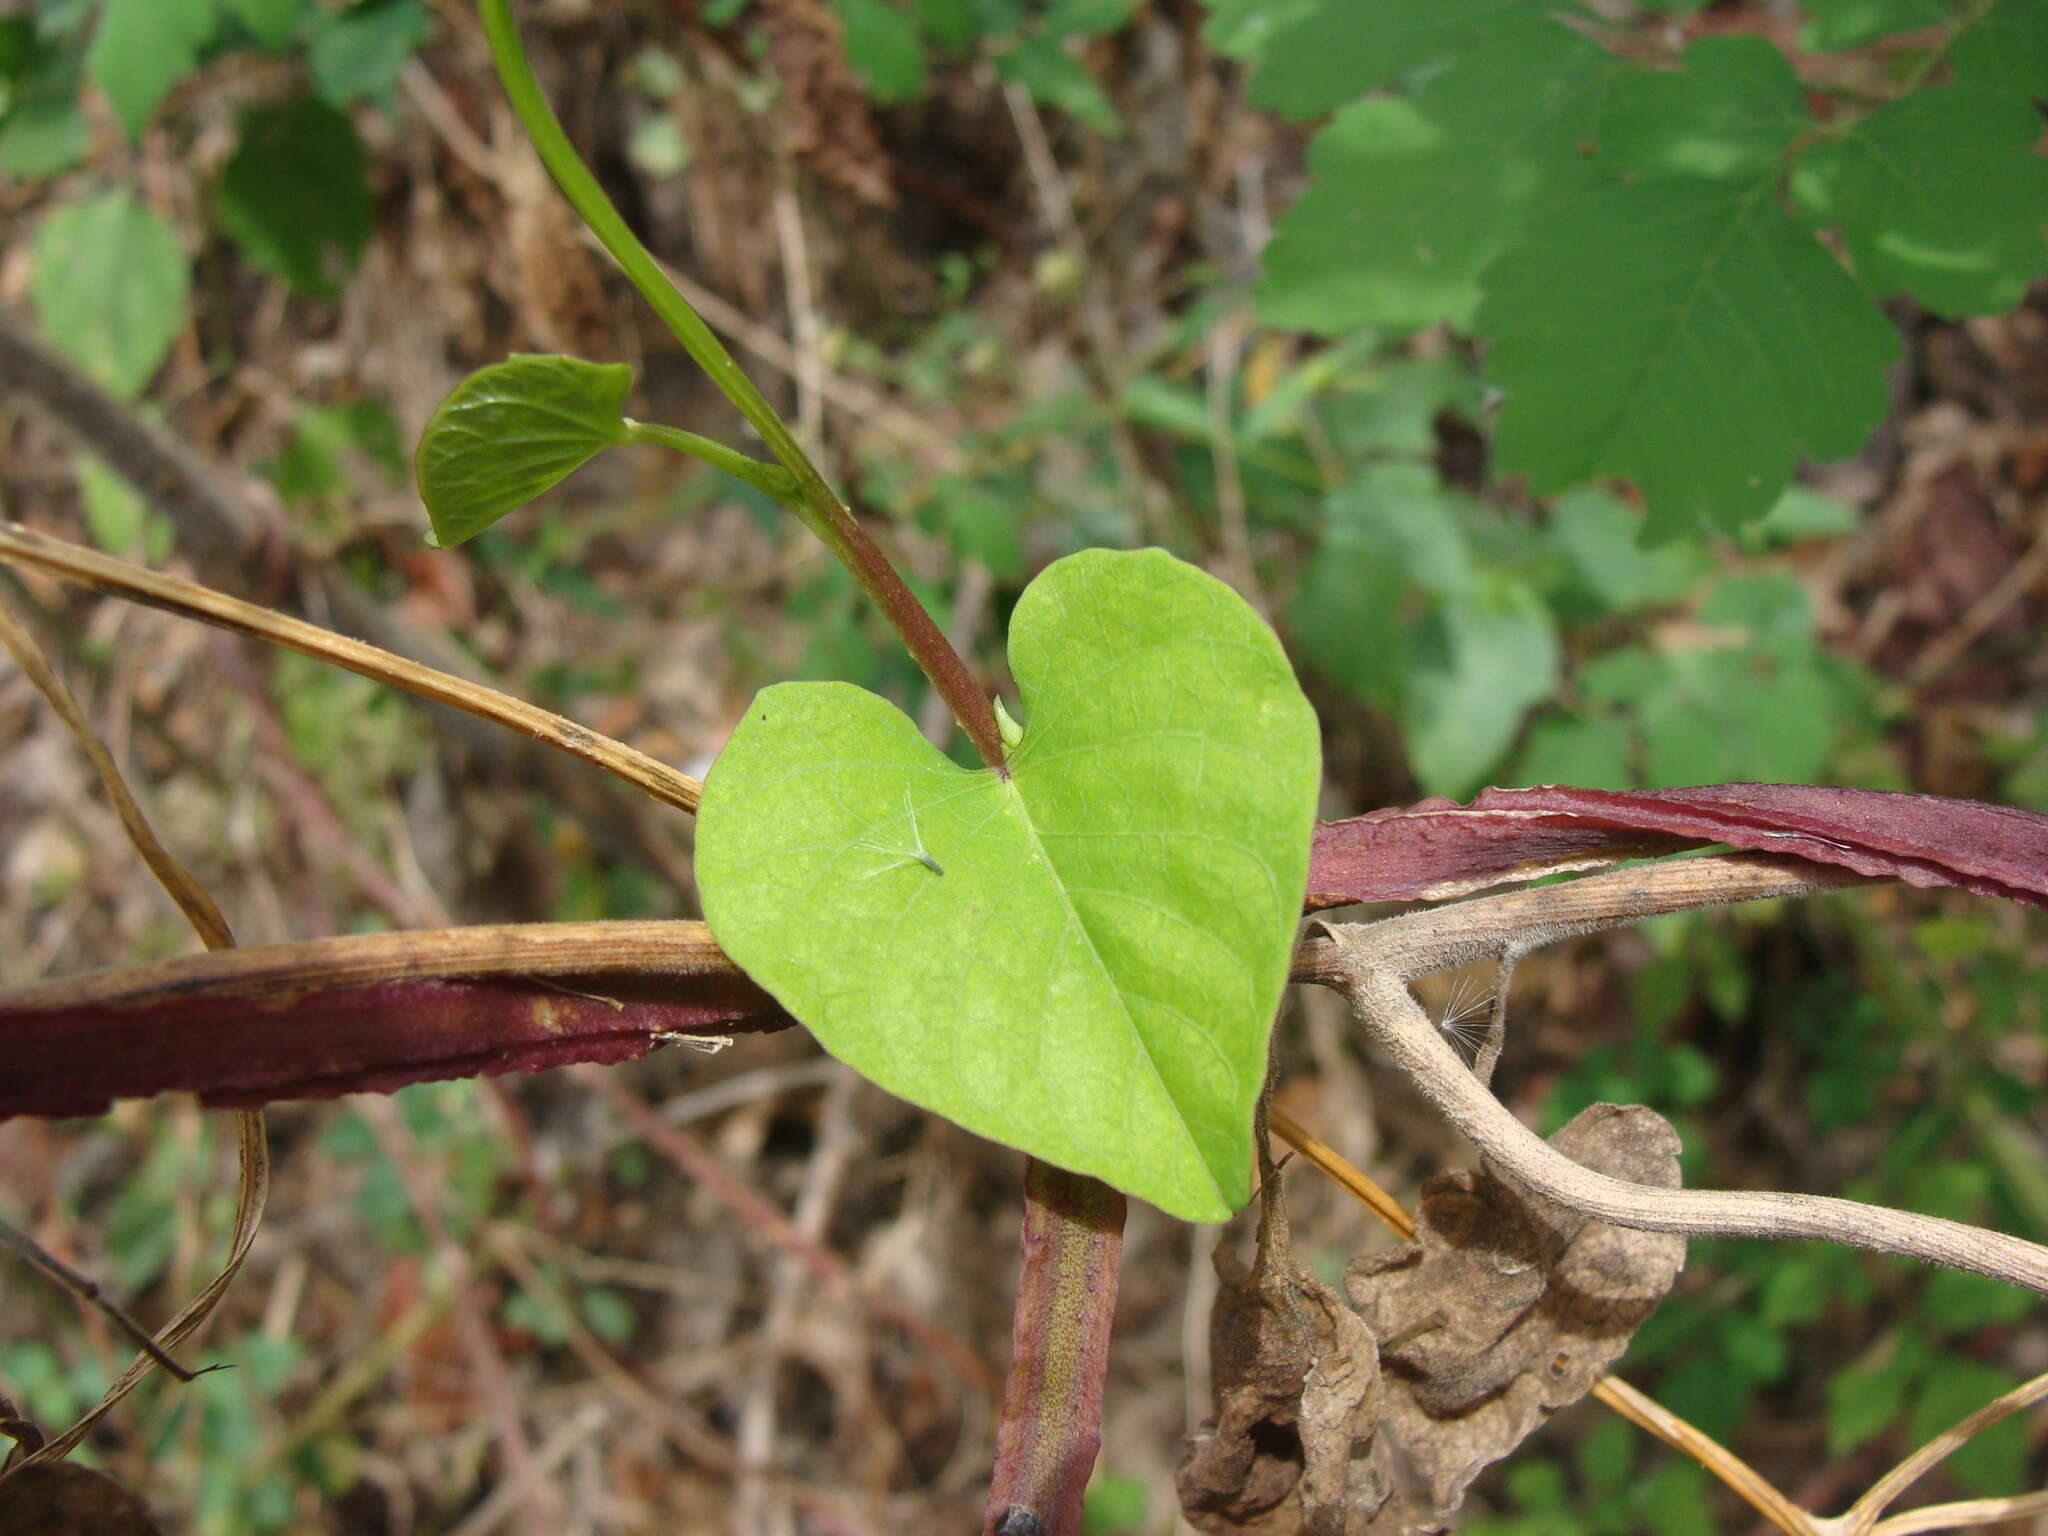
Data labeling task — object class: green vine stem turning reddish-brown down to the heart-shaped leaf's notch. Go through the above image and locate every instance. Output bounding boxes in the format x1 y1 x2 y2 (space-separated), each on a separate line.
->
477 0 1004 770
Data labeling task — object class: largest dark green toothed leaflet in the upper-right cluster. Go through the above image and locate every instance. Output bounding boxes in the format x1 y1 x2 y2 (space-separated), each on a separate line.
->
1477 176 1898 537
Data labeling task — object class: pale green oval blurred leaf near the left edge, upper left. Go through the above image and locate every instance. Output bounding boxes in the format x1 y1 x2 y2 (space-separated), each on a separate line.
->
29 188 193 397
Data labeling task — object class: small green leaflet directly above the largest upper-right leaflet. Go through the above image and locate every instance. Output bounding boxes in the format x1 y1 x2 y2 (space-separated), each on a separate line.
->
1599 37 1812 176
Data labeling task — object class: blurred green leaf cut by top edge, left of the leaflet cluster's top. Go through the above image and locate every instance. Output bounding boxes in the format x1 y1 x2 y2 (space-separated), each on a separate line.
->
1251 0 1544 121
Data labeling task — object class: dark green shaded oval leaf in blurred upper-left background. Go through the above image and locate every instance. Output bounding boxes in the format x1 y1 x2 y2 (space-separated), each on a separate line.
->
213 96 375 299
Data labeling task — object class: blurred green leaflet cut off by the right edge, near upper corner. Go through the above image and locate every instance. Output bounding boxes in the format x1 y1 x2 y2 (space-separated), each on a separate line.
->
1794 86 2048 319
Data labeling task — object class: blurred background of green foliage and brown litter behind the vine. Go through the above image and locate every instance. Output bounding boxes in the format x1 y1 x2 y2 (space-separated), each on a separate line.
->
0 0 2048 1534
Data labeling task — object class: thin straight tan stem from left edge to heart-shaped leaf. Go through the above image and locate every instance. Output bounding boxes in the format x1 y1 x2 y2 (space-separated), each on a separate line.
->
0 522 702 811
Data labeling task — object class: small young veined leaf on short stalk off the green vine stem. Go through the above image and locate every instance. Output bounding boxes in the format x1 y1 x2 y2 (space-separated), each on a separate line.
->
414 352 633 549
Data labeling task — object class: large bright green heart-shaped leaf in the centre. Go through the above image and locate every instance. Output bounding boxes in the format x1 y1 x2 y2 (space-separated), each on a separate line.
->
696 551 1321 1221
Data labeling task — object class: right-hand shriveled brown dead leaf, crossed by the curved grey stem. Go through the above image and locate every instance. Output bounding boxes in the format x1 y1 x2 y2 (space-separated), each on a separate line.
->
1348 1104 1686 1532
